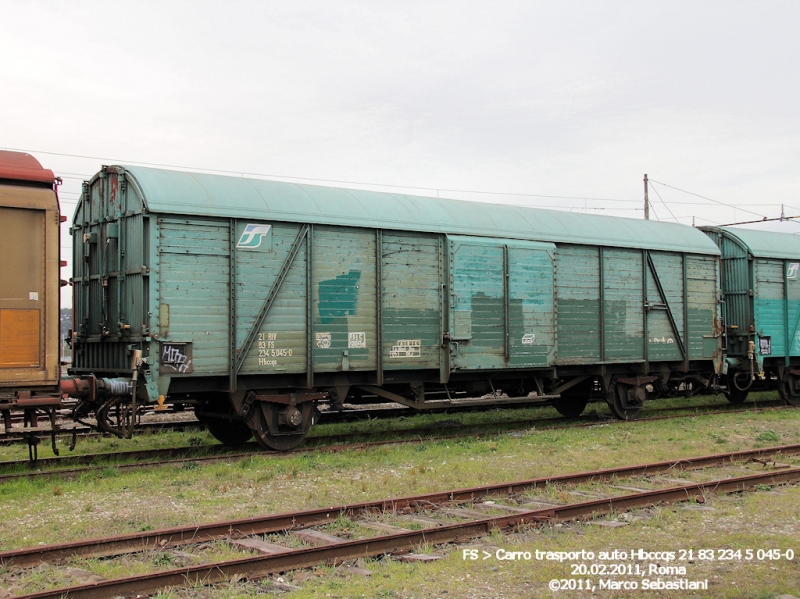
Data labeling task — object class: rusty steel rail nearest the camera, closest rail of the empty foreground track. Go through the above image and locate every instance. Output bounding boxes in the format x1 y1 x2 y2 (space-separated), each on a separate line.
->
16 468 800 599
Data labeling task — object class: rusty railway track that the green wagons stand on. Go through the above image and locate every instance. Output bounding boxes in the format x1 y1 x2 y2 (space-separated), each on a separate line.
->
0 405 789 483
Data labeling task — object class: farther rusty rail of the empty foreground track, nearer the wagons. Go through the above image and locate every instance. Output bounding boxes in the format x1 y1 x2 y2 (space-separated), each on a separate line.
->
0 444 800 567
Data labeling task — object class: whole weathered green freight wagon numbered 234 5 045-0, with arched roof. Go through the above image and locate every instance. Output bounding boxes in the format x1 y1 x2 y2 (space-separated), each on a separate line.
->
72 166 721 449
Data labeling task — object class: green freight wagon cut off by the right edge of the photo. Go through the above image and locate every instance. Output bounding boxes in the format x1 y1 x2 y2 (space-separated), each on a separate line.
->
703 227 800 405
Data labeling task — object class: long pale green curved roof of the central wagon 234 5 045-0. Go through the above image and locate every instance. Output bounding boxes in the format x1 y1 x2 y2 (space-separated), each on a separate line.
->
116 166 719 254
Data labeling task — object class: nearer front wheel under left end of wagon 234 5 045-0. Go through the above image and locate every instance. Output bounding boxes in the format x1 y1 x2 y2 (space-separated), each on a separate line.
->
250 401 314 451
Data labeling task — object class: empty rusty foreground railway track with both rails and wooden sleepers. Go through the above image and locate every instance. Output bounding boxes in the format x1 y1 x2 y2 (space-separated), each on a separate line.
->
0 445 800 599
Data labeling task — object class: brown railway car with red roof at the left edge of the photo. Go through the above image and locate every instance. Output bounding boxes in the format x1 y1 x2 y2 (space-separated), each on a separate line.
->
0 151 61 454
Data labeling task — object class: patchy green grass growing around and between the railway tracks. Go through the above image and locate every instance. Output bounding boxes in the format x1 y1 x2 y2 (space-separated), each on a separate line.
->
0 397 800 599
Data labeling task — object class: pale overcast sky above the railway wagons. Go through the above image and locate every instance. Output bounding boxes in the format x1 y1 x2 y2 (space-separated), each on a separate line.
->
0 0 800 304
